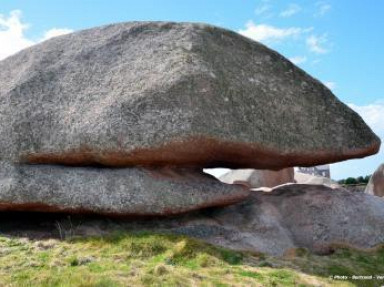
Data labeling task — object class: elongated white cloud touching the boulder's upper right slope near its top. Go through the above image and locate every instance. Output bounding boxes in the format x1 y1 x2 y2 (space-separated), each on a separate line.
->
239 21 310 43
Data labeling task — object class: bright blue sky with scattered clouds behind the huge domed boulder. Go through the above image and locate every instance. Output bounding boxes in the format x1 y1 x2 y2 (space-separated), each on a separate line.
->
0 0 384 179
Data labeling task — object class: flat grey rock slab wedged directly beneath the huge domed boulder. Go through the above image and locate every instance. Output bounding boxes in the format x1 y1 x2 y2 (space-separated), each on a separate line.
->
0 163 249 216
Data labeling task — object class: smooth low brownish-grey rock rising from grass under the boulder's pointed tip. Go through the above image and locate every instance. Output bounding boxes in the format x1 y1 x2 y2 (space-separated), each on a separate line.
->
178 184 384 255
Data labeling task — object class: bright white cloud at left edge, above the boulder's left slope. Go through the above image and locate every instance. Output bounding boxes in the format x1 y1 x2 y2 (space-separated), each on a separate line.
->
0 10 72 60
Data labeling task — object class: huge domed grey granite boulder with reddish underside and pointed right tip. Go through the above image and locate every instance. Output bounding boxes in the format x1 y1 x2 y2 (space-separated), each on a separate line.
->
0 22 380 169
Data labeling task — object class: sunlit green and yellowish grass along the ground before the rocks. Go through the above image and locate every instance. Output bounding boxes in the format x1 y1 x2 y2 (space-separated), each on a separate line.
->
0 232 384 287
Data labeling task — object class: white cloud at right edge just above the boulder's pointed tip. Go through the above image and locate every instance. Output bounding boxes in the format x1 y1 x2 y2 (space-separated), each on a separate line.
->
348 102 384 134
